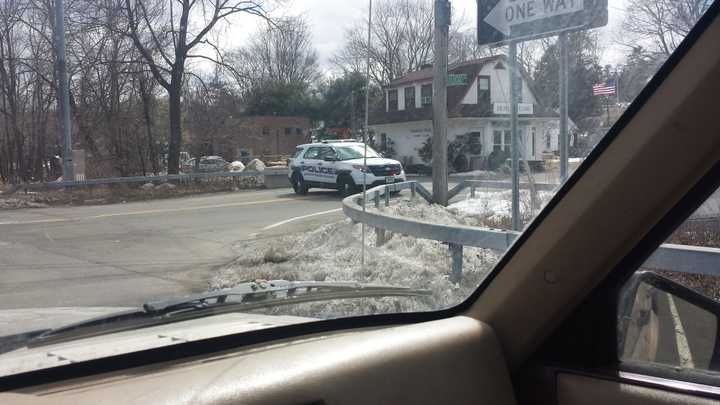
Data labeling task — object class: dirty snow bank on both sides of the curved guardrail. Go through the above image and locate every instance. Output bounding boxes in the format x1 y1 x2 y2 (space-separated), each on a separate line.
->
209 190 552 318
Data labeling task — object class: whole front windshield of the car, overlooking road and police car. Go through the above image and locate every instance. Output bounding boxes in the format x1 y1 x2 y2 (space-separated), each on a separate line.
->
0 0 720 376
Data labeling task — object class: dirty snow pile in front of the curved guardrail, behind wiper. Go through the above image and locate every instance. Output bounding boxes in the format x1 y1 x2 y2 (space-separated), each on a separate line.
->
209 220 499 318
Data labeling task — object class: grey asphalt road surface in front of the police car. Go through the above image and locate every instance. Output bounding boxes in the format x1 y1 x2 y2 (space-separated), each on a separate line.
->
0 189 343 309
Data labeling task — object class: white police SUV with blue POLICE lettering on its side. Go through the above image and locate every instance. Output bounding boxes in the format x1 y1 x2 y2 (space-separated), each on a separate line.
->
288 140 405 196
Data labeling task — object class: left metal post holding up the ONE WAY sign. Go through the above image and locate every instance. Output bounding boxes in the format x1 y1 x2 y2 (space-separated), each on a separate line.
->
508 41 521 231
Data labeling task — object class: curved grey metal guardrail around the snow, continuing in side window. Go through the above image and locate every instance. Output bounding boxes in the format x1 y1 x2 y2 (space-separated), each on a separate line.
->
343 180 720 282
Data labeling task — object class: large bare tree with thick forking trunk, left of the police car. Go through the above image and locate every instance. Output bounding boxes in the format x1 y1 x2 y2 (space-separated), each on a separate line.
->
124 0 267 173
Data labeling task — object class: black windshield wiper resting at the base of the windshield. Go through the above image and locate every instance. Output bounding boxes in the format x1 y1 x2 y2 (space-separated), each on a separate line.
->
27 280 432 347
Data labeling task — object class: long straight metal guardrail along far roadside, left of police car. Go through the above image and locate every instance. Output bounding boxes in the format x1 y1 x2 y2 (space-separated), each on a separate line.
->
17 169 287 190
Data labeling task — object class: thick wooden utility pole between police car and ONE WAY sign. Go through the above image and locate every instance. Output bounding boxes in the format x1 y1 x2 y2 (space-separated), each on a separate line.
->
432 0 451 206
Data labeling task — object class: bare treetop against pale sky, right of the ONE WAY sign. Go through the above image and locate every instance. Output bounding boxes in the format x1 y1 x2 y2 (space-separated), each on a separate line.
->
621 0 713 56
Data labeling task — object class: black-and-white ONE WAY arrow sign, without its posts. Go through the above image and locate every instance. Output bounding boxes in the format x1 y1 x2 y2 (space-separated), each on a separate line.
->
478 0 608 45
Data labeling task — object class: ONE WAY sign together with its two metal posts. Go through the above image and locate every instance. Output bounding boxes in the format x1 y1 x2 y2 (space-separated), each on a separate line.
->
477 0 608 230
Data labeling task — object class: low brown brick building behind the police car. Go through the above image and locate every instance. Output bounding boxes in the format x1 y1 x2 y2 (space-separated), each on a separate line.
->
208 116 311 161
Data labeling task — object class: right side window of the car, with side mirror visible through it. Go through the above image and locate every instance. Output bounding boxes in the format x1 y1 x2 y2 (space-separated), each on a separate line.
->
618 185 720 376
